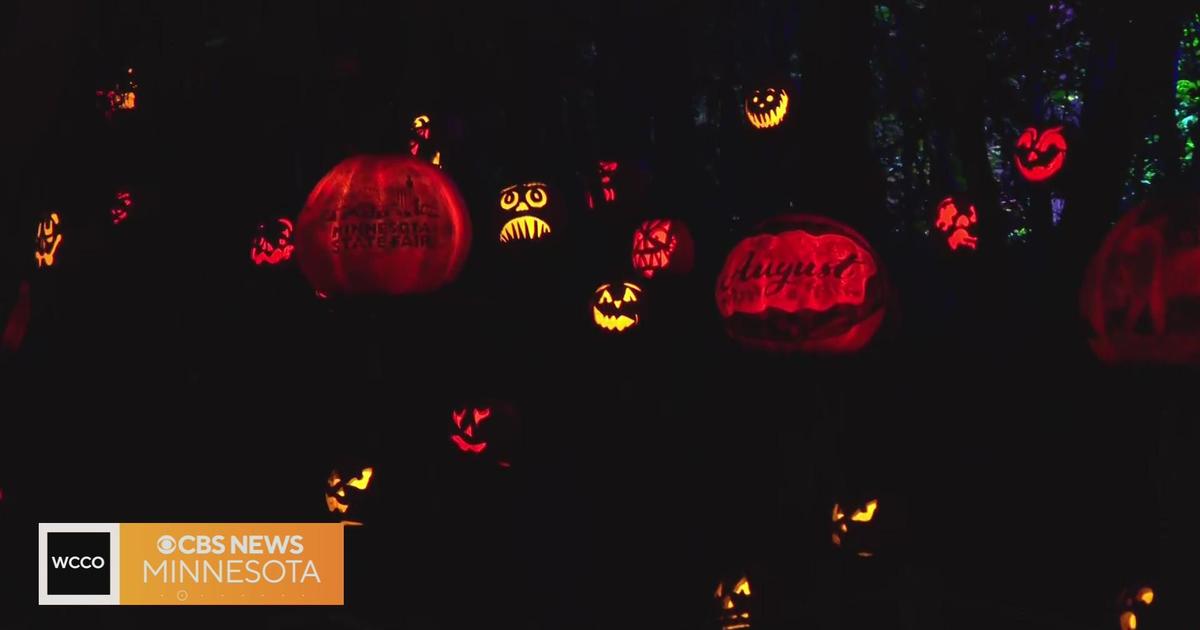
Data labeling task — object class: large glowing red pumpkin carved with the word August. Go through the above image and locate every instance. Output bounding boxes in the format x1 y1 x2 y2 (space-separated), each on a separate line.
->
716 215 887 353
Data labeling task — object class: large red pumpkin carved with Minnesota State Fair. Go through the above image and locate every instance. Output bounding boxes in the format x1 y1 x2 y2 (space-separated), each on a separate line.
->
295 155 470 294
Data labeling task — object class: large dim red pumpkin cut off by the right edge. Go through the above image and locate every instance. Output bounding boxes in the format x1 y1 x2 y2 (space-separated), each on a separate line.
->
1080 197 1200 364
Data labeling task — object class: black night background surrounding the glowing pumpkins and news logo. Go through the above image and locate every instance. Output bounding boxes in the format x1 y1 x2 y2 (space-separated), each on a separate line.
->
0 0 1200 630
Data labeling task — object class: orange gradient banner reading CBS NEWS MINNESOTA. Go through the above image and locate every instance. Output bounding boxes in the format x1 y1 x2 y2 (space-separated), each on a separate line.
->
120 523 343 606
